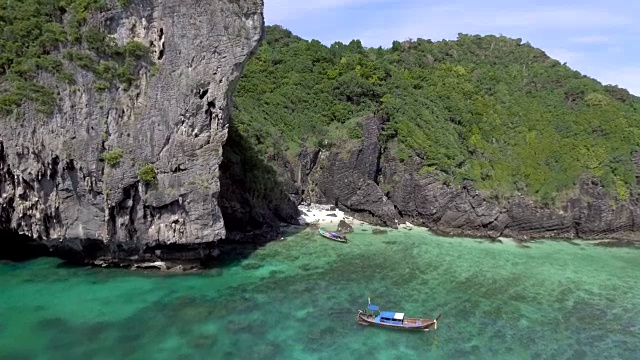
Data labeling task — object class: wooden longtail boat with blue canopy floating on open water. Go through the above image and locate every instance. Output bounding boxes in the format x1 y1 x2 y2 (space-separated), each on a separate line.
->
356 299 442 331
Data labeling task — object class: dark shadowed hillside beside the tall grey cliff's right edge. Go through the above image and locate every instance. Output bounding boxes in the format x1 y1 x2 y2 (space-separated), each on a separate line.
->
218 120 303 264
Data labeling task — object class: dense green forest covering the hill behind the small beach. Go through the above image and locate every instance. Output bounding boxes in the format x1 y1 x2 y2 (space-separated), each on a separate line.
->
232 26 640 204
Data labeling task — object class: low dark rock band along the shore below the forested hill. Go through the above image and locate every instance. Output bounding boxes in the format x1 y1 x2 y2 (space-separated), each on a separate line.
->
288 118 640 245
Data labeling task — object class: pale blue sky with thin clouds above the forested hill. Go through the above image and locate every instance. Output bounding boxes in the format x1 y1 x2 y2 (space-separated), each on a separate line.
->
264 0 640 96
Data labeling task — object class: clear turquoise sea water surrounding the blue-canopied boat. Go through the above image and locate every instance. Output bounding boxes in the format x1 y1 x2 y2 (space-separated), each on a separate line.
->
0 226 640 360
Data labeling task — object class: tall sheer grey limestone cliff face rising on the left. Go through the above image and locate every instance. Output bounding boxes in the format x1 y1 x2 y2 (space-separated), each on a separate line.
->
0 0 278 264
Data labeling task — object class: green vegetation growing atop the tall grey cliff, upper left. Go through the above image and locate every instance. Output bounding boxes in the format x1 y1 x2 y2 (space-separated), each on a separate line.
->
0 0 148 114
